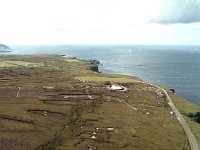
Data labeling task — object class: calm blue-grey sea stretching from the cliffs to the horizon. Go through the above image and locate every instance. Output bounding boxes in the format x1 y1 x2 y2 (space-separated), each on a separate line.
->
6 45 200 105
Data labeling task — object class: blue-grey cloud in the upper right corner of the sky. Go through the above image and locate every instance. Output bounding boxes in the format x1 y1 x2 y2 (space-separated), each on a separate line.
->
152 0 200 24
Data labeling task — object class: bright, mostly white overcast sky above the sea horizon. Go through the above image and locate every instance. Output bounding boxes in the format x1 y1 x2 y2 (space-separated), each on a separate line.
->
0 0 200 45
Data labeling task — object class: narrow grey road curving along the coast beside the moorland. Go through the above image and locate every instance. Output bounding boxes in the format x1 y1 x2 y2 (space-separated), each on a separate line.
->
150 84 199 150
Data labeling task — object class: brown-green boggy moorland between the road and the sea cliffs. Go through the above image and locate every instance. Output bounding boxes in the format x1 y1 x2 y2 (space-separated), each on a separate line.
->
0 55 190 150
